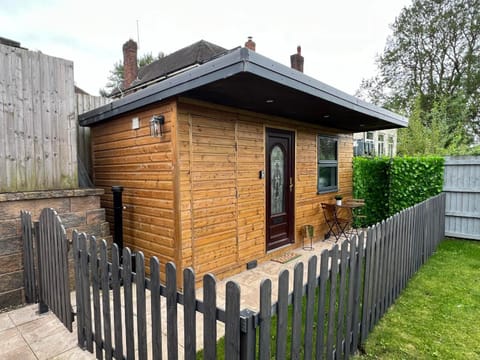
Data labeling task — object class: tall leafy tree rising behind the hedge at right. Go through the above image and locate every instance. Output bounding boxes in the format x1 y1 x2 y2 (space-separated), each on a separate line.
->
358 0 480 153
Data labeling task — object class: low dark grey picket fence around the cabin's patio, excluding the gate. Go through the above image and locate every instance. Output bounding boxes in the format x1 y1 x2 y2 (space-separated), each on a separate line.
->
74 194 445 359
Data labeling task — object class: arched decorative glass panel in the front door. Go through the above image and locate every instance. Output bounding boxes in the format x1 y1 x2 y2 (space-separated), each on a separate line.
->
270 145 285 215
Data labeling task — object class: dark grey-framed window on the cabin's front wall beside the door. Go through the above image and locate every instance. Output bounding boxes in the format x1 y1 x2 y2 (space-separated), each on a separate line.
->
317 135 338 193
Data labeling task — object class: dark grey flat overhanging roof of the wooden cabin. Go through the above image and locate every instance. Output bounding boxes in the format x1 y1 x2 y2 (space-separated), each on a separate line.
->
79 48 408 132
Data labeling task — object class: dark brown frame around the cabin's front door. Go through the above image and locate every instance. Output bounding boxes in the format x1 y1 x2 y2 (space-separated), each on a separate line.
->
265 127 296 252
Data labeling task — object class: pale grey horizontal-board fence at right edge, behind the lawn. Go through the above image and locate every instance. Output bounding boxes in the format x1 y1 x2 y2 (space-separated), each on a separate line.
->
443 156 480 240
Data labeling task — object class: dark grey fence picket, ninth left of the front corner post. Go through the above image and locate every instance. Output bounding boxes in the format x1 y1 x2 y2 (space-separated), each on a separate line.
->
99 240 113 359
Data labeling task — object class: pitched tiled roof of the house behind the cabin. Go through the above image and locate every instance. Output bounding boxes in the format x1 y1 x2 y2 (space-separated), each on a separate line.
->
131 40 227 87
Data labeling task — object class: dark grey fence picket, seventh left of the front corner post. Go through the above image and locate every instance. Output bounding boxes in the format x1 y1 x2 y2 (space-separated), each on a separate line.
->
122 248 135 360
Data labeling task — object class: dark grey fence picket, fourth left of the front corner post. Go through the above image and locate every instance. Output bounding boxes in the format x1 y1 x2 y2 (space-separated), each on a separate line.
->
166 262 178 360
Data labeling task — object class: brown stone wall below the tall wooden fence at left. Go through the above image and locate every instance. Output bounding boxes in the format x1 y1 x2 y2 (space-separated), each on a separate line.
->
0 189 111 309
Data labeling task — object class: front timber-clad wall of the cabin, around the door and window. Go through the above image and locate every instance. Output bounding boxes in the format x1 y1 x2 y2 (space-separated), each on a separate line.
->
178 100 353 277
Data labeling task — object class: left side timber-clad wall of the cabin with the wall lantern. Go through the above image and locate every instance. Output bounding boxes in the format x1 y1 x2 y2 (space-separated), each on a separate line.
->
91 101 176 264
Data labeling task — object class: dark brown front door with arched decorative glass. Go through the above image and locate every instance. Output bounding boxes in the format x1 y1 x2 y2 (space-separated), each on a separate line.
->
265 129 295 251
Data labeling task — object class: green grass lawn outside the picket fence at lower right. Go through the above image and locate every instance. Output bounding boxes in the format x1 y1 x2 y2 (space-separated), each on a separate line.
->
354 239 480 360
